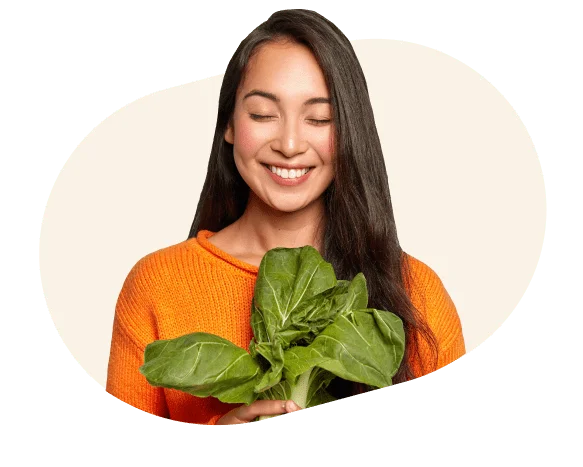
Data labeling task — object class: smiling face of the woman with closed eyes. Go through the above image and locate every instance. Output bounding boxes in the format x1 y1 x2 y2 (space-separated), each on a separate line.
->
225 42 334 212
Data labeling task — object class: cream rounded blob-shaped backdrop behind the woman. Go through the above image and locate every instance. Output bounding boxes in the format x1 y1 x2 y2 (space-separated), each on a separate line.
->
38 38 548 387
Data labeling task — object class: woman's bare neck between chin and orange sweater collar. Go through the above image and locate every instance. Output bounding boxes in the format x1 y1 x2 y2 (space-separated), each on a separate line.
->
230 195 325 256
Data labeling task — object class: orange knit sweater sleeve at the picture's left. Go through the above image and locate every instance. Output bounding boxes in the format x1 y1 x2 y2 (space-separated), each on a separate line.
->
106 257 170 418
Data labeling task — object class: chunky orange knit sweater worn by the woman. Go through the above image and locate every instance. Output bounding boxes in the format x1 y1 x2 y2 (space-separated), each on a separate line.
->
106 230 465 425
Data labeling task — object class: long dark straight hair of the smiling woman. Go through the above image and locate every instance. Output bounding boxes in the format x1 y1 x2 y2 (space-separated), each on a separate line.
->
189 9 437 396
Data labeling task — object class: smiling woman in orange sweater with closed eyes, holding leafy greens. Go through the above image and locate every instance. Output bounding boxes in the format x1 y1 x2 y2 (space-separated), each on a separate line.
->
107 10 465 425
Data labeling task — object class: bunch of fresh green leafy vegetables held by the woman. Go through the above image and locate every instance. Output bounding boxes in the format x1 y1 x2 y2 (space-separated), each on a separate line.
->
140 245 405 408
